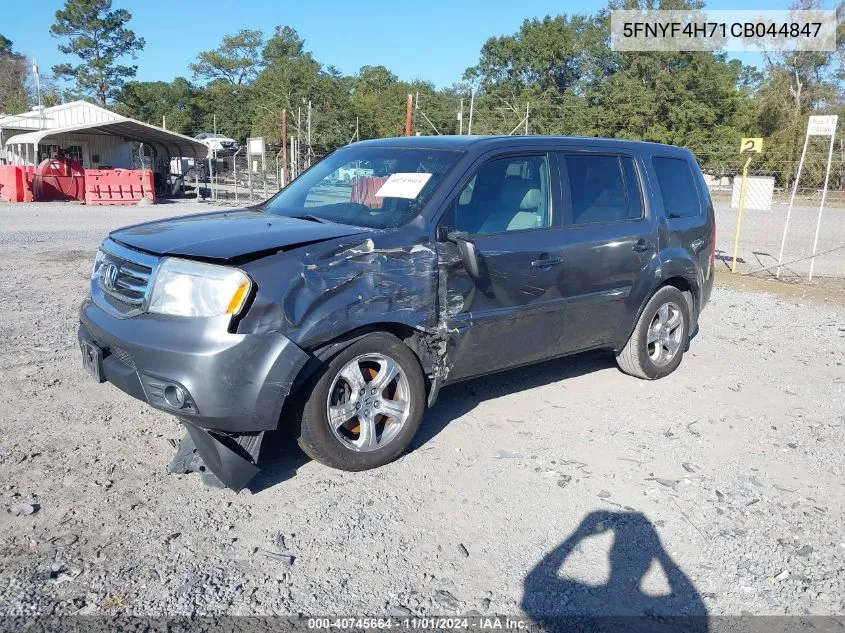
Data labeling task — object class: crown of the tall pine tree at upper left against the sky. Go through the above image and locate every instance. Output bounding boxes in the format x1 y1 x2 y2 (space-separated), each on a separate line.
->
50 0 144 105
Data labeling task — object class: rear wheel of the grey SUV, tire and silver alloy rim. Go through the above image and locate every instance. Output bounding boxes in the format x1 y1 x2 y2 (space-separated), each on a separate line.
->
616 286 690 380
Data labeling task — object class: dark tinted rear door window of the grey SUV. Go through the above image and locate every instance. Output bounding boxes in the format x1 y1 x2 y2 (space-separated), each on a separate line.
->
563 154 643 224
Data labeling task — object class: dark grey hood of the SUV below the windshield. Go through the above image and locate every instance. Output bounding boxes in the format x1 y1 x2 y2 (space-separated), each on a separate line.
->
110 209 364 259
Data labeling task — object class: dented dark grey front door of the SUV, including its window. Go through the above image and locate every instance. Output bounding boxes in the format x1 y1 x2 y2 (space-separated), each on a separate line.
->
441 154 565 380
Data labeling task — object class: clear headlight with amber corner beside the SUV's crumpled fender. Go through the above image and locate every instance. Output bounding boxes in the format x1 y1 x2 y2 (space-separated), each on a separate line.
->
147 258 252 317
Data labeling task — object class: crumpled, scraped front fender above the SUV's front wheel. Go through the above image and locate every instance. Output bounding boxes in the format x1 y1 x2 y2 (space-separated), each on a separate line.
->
238 234 438 350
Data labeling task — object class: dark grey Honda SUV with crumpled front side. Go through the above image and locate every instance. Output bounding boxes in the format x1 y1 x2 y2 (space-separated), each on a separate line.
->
79 136 715 489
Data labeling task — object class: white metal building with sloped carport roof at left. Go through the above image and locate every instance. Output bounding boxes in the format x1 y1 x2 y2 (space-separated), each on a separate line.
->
0 101 209 169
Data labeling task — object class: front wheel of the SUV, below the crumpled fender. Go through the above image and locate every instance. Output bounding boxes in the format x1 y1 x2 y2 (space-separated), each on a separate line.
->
298 332 425 471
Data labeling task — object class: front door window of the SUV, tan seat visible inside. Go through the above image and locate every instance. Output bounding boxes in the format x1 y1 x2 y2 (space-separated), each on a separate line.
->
455 155 551 235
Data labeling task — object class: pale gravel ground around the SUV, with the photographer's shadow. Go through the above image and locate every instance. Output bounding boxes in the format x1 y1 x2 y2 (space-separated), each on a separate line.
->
0 204 845 620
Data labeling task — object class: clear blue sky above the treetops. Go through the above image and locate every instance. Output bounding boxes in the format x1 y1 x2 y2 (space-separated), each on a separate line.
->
0 0 835 88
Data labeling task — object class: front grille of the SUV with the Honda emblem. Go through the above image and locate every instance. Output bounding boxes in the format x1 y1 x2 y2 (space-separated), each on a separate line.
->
92 240 156 315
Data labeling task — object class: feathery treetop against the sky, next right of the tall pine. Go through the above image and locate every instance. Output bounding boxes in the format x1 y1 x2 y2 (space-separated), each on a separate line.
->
191 29 264 85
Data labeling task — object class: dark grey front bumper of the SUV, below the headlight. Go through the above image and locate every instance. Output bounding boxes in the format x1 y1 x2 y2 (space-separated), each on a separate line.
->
78 298 309 433
